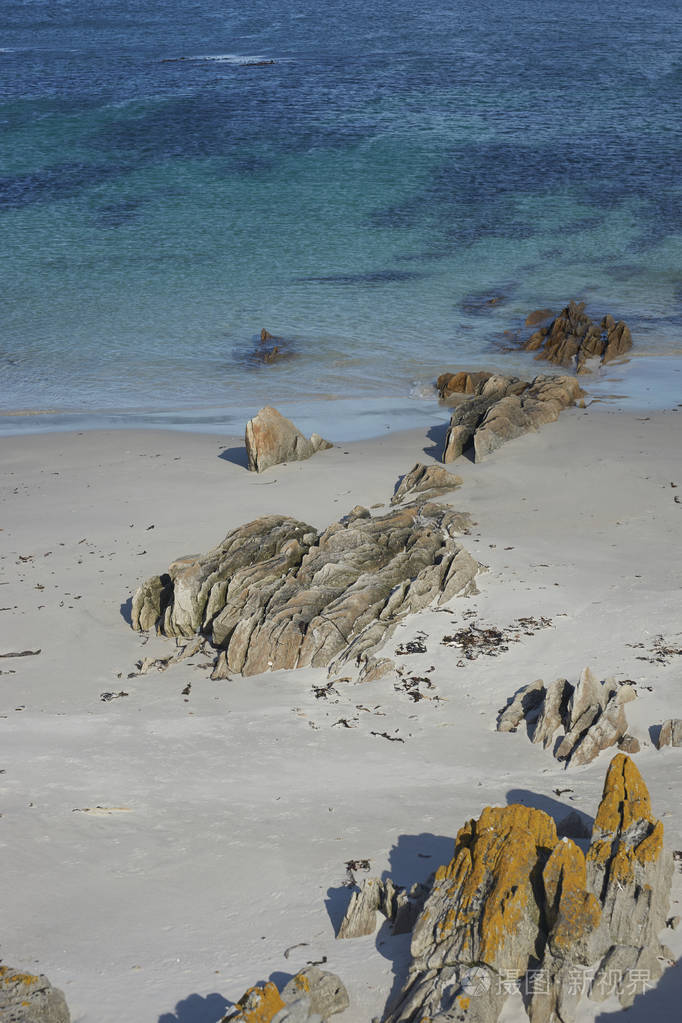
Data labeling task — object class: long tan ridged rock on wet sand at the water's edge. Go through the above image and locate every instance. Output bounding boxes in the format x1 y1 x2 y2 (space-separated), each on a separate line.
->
441 374 584 462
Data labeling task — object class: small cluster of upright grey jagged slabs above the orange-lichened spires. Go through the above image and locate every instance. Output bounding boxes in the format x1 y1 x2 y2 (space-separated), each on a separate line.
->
497 668 636 766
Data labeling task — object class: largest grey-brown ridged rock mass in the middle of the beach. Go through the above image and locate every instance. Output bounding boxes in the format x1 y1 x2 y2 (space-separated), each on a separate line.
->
132 502 480 675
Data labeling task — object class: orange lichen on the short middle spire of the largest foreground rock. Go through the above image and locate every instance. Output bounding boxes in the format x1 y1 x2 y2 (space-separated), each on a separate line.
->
542 839 601 950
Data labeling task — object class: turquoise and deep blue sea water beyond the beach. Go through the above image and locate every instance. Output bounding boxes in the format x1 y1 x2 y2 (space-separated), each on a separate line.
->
0 0 682 430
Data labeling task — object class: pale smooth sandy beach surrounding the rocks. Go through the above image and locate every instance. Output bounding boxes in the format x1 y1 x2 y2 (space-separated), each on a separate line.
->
0 404 682 1023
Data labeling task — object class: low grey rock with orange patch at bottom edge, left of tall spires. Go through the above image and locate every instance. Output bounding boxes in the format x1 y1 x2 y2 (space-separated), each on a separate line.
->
221 966 349 1023
